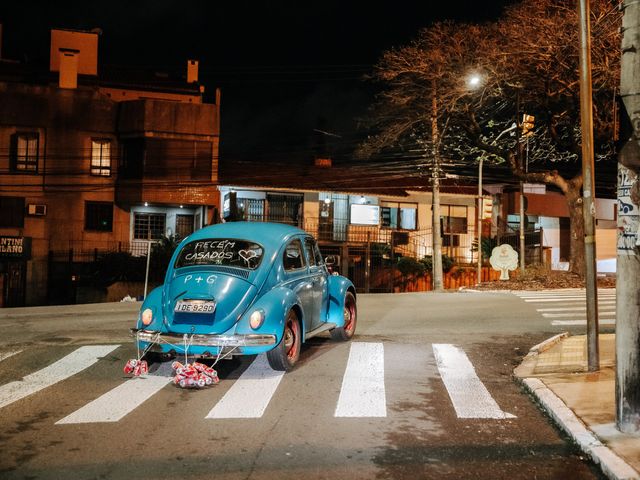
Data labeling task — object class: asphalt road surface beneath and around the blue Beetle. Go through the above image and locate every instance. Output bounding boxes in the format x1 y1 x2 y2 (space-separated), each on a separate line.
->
0 293 600 479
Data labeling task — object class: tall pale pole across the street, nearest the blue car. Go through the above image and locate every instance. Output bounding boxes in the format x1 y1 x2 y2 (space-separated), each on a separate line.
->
431 79 444 292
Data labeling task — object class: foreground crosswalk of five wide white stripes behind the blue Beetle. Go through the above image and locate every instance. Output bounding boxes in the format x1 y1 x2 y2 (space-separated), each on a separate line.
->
0 341 514 426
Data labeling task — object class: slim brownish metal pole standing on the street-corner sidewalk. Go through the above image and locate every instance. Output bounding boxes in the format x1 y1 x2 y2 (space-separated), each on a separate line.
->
578 0 600 372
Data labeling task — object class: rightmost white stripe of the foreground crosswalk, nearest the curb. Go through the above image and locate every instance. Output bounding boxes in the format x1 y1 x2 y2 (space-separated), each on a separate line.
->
432 344 516 418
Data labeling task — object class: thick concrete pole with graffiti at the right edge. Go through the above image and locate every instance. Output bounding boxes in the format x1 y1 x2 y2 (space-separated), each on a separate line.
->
616 0 640 434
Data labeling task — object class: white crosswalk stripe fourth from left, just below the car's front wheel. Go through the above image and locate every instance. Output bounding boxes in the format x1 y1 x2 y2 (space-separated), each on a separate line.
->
334 342 387 417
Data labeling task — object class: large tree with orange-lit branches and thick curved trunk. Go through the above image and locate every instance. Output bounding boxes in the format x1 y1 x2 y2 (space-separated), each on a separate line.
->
360 0 621 274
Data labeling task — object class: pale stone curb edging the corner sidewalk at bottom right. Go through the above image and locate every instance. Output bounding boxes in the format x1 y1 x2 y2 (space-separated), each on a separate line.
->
519 378 640 480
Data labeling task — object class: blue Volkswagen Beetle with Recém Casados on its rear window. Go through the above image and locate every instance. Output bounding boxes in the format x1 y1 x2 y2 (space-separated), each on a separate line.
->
132 222 357 370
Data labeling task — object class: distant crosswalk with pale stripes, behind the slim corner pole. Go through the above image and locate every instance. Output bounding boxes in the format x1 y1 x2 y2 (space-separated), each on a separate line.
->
514 288 616 326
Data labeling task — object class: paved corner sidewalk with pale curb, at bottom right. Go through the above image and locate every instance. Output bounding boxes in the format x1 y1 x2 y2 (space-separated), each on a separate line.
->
514 334 640 479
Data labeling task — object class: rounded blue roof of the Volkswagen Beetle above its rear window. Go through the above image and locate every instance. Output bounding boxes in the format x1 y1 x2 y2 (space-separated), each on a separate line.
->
182 222 307 249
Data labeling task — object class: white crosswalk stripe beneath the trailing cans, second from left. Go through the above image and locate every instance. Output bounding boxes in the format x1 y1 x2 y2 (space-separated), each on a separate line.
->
56 375 171 425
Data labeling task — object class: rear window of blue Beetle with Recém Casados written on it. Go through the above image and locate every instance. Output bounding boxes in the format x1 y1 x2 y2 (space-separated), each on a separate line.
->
175 238 264 270
